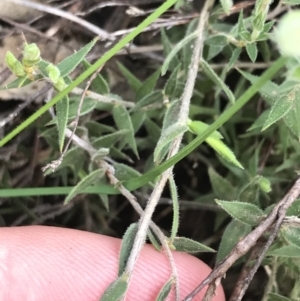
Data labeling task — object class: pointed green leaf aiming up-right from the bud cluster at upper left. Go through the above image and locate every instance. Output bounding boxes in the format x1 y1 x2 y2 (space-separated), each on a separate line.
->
57 38 98 77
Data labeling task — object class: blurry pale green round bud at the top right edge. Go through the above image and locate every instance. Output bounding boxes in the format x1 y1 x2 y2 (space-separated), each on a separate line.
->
274 10 300 57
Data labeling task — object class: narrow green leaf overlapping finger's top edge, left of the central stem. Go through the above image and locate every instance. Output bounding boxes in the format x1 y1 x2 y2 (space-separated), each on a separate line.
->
118 223 138 277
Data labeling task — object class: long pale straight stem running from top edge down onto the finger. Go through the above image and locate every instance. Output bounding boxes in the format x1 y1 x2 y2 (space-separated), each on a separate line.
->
125 0 214 296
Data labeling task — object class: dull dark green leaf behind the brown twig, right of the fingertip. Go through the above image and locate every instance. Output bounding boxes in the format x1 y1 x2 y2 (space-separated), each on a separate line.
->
216 220 251 264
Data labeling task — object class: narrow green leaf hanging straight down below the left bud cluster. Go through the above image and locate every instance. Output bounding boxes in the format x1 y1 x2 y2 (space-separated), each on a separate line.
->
56 95 69 152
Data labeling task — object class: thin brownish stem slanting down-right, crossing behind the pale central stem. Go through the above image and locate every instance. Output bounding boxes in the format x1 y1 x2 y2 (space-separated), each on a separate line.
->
66 128 179 296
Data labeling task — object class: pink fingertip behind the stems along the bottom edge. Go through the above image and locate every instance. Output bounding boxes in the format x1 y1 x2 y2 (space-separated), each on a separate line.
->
0 226 225 301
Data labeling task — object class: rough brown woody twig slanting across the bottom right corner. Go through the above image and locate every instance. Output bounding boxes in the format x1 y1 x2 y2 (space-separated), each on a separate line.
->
183 178 300 301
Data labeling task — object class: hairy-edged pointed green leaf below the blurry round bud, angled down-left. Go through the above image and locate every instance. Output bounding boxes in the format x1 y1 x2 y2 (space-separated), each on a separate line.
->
262 94 295 131
